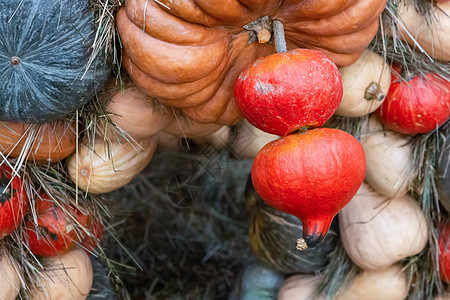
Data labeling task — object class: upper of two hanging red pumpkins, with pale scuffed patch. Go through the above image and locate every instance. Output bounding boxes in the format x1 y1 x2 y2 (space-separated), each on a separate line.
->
234 49 343 136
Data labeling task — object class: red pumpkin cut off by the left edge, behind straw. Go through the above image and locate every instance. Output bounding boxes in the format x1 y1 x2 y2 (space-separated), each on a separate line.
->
0 165 28 240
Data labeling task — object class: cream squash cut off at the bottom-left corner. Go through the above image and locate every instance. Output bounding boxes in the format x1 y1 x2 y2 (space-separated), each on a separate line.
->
0 249 23 300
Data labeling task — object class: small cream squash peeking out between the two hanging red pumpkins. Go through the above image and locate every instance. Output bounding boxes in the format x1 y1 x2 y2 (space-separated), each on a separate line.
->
230 120 279 158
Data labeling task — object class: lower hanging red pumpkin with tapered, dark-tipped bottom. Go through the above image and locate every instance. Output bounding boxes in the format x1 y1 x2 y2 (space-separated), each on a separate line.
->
252 128 366 247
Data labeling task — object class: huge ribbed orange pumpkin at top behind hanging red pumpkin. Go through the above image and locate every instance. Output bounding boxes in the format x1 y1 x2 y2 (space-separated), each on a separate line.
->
117 0 386 125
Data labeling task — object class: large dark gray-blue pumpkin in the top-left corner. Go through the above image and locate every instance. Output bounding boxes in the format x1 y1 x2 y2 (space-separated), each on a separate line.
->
0 0 110 123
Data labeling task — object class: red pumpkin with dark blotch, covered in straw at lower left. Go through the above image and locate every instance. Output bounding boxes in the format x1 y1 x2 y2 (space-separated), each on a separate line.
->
25 195 91 257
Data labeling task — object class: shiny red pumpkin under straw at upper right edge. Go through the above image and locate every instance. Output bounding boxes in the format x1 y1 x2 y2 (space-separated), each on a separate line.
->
376 73 450 134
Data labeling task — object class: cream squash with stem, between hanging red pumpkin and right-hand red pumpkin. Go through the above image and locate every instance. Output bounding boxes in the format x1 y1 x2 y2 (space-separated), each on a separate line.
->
336 49 391 117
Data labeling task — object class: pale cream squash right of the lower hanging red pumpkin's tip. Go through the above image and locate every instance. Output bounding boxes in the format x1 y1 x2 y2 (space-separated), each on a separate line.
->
339 184 428 270
